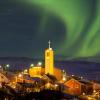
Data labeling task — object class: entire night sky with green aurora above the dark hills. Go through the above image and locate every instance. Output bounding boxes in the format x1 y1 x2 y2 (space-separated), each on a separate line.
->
0 0 100 58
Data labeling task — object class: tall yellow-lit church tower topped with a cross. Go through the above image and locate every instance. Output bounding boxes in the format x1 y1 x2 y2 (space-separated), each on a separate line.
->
45 41 54 75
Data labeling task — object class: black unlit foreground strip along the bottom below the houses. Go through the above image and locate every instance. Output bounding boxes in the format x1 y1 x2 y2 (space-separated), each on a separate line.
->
0 90 81 100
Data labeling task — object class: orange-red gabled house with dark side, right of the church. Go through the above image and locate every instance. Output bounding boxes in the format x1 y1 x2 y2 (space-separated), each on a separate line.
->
64 78 93 95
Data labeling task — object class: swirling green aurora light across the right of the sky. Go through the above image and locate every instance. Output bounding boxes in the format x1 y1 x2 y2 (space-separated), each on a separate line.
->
17 0 100 57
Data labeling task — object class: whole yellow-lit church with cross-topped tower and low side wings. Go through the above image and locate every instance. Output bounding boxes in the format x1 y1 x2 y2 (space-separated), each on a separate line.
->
29 41 62 80
